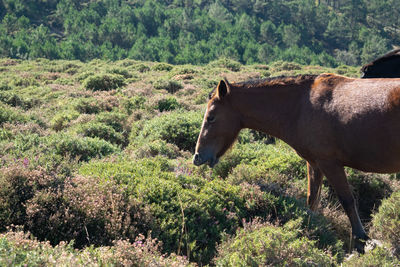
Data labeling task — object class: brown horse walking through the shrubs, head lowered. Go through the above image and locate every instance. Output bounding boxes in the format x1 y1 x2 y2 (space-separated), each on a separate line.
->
193 74 400 250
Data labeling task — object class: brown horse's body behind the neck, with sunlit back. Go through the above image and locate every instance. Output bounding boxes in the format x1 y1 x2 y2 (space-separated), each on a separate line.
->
302 74 400 172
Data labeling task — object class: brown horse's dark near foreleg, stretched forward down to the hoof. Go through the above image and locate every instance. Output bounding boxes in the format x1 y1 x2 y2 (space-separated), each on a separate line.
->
318 162 368 251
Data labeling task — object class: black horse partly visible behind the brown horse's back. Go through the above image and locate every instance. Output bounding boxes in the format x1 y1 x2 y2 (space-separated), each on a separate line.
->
361 49 400 78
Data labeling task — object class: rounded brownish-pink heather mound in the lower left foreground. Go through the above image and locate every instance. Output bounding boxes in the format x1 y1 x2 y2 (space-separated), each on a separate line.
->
25 176 152 248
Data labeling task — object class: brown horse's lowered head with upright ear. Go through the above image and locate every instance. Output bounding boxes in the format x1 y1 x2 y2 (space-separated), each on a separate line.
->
193 80 241 167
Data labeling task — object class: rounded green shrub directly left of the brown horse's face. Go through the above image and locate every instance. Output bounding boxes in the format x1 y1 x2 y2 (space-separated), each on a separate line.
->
130 111 202 151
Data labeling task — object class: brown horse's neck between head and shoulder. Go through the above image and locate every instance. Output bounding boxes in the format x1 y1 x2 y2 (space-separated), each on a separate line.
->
232 85 306 141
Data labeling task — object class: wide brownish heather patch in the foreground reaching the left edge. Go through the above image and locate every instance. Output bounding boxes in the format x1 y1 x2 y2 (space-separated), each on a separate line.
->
0 165 153 250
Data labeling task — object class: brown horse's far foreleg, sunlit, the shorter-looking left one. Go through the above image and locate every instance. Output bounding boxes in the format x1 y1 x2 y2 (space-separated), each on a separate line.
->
307 162 323 211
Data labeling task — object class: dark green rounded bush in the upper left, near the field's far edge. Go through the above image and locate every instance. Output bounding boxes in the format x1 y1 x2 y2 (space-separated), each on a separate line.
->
82 73 125 91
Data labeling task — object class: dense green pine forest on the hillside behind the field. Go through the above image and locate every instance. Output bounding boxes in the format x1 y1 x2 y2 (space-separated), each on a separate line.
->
0 0 400 66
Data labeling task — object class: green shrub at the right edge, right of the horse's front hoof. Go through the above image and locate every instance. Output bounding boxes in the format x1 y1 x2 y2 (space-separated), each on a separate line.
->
370 191 400 259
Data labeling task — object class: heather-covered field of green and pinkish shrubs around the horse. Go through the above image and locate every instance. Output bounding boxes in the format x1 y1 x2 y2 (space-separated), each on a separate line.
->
0 58 400 266
